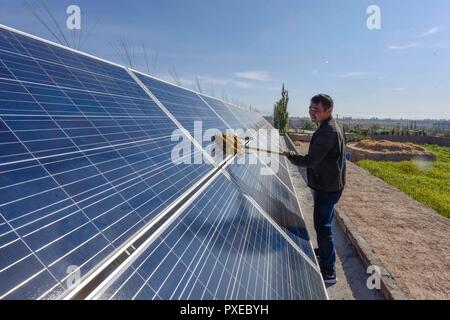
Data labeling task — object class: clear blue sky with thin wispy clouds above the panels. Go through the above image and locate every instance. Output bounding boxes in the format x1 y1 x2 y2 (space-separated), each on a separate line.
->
0 0 450 119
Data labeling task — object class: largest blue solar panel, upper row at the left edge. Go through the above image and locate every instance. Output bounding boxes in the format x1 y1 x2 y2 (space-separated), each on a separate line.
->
0 29 212 299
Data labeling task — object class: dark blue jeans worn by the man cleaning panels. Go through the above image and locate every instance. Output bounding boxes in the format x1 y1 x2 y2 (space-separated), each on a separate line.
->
312 190 342 275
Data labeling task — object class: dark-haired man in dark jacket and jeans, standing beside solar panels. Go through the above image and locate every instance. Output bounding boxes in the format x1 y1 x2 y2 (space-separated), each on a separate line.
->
288 94 346 284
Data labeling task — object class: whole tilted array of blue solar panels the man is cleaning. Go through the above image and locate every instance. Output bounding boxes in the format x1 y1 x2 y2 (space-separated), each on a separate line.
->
0 26 326 299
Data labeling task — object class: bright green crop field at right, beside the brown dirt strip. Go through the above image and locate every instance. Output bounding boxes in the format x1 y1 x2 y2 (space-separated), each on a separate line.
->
358 145 450 219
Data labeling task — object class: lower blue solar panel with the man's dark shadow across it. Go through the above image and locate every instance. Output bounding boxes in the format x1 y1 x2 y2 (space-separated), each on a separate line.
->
97 175 326 300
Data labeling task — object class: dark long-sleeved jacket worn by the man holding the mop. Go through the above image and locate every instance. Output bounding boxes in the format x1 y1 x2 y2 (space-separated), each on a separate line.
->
289 117 346 192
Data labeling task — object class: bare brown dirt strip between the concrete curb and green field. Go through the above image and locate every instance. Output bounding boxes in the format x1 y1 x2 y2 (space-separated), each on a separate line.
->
339 163 450 299
